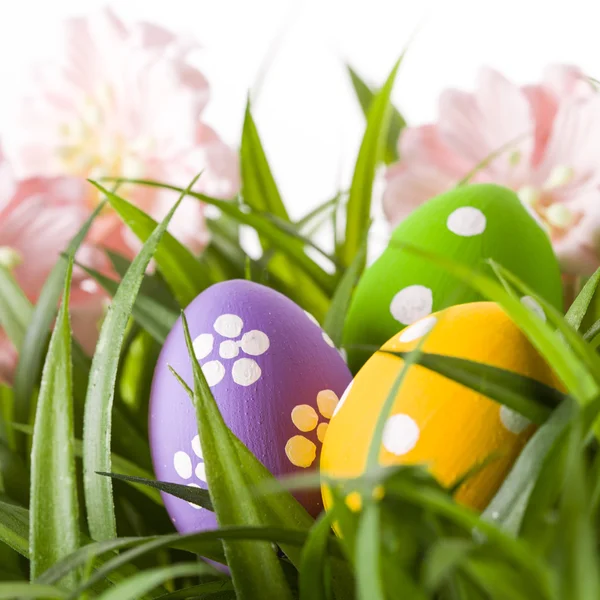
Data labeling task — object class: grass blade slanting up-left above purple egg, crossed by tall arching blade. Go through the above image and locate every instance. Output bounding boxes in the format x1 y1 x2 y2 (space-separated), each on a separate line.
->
91 176 213 306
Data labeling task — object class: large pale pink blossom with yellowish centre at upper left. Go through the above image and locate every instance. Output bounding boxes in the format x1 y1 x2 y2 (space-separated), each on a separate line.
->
5 10 239 256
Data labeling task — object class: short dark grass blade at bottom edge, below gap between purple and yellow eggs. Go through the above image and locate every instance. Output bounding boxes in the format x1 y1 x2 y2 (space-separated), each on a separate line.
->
298 513 331 600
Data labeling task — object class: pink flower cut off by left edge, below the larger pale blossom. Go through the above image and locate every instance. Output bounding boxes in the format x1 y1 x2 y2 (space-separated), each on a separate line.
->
0 155 108 382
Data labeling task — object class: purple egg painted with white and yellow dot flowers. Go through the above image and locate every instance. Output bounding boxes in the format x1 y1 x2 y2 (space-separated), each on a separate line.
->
149 280 352 532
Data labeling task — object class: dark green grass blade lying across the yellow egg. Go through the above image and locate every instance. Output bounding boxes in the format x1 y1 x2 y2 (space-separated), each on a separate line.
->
385 351 568 425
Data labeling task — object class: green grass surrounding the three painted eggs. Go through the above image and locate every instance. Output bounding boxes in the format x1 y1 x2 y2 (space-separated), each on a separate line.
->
0 62 600 600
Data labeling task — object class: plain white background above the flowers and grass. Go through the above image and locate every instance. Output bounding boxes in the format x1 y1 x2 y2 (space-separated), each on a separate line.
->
0 0 600 223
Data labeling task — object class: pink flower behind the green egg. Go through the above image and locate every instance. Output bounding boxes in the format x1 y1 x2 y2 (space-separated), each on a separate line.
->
383 66 600 274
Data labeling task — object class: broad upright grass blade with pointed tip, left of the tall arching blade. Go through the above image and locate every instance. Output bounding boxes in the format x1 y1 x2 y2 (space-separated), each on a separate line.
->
29 259 79 585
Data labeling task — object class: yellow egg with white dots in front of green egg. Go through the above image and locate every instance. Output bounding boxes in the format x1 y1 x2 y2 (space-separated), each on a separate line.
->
321 298 561 509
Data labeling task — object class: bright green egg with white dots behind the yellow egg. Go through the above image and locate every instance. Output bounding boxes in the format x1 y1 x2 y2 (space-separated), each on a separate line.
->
343 184 562 373
